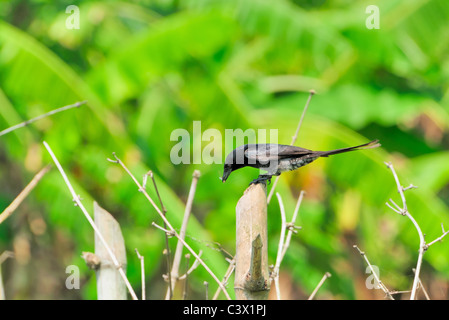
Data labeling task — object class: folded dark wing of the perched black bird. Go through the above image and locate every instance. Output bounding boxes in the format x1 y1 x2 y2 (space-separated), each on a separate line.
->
245 144 313 162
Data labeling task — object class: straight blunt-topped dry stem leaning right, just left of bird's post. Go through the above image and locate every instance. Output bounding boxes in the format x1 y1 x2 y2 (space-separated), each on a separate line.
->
165 170 200 300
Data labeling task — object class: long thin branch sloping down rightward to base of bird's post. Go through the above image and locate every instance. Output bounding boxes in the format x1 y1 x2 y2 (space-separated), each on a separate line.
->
110 153 231 300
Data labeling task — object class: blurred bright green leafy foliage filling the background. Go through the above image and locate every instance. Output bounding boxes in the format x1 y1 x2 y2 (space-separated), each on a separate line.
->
0 0 449 299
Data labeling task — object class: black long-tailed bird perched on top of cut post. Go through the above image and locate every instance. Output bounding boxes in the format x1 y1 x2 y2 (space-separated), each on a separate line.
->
221 139 380 185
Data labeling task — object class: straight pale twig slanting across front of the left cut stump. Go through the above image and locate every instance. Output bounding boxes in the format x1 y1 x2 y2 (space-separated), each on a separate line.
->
43 141 137 300
